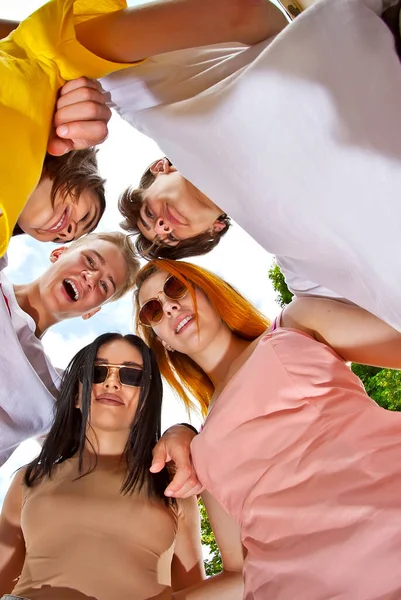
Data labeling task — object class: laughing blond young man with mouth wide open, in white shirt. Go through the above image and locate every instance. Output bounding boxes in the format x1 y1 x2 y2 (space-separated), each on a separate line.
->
0 232 139 465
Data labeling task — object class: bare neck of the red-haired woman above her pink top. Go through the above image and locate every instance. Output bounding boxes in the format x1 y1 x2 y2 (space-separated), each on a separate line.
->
190 328 252 388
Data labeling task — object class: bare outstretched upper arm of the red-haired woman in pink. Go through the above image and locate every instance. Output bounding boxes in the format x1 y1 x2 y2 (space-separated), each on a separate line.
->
281 298 401 369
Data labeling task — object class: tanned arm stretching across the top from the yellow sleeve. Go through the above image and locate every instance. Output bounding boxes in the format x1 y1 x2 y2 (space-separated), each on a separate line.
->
77 0 287 62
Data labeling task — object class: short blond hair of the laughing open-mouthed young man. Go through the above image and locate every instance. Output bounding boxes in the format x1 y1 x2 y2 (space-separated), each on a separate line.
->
68 231 140 302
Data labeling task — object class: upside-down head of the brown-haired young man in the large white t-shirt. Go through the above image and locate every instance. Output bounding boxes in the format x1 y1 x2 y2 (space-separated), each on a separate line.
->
118 157 231 260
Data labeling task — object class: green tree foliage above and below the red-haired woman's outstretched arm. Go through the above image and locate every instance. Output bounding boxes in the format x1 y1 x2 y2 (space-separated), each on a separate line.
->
269 263 401 411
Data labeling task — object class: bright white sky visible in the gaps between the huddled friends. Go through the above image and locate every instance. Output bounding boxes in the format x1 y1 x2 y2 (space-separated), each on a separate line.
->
0 0 278 505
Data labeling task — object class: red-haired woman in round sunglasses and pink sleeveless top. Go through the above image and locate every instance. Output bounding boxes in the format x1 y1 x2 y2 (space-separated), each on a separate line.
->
136 260 401 600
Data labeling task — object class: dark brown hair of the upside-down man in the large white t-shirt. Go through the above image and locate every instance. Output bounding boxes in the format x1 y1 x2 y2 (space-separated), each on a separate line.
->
118 157 231 260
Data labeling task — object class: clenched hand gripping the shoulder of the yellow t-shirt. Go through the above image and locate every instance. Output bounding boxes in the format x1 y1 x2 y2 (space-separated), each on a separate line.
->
47 77 111 156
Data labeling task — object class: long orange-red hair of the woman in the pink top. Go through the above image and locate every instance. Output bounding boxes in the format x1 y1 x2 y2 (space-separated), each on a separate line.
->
135 259 270 414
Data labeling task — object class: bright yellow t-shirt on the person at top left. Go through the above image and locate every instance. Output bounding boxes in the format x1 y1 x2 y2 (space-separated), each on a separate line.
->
0 0 139 256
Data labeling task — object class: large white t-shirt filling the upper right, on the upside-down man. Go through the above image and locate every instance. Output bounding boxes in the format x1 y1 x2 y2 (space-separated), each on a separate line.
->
102 0 401 330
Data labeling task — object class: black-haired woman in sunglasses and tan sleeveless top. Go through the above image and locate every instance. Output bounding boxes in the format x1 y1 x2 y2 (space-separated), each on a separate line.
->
0 333 242 600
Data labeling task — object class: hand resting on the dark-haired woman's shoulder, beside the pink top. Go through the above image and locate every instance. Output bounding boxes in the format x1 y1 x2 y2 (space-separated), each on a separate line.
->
150 425 203 498
